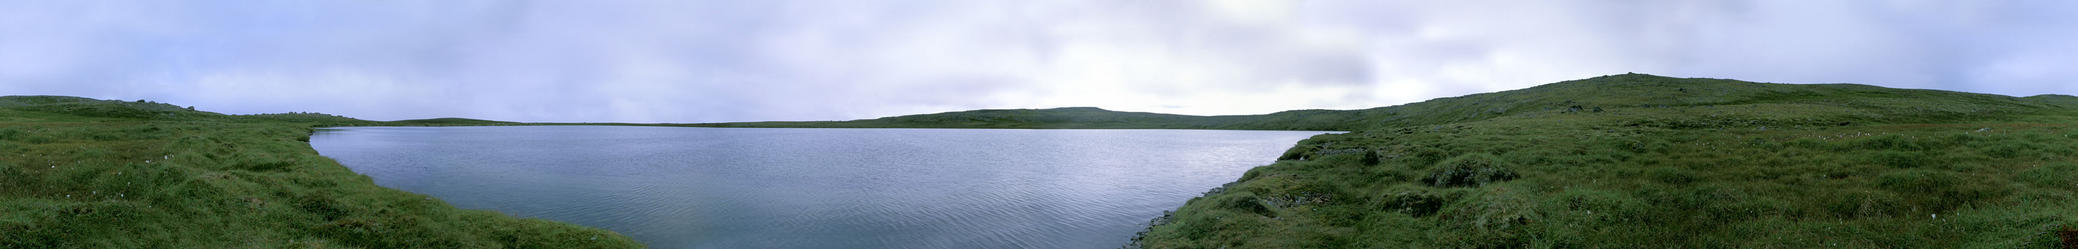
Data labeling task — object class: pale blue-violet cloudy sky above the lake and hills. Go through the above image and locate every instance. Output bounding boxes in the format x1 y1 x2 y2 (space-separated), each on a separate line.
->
0 0 2078 122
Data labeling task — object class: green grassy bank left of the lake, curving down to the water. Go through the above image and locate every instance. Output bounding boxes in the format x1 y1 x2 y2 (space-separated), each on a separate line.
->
0 95 640 249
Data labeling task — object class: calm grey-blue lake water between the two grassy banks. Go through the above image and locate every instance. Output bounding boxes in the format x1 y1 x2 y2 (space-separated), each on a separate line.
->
310 127 1320 249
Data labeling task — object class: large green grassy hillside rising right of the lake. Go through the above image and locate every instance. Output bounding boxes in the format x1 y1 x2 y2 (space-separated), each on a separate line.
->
1133 75 2078 249
